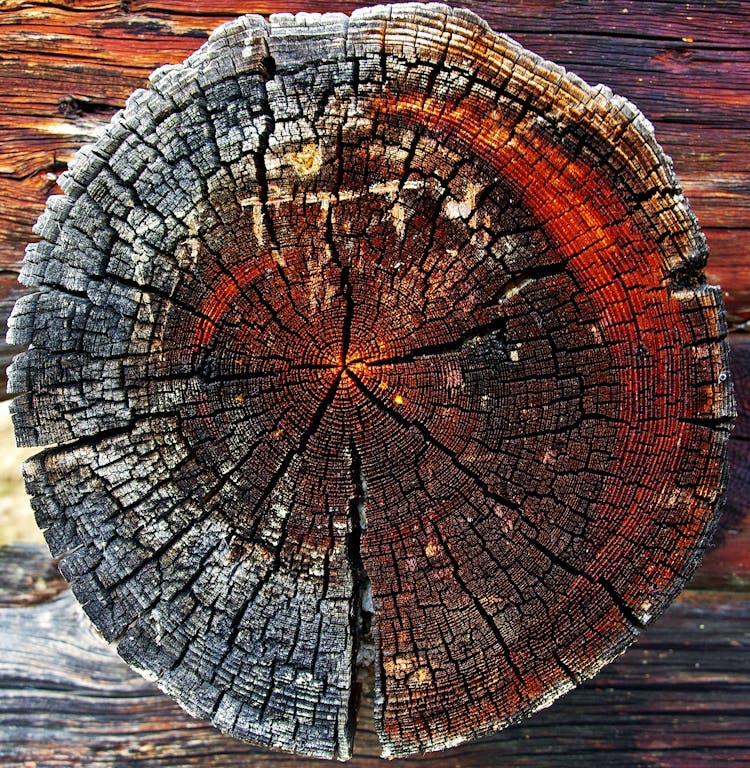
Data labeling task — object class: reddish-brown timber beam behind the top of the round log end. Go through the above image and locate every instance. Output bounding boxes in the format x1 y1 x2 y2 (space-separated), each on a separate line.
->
0 0 750 396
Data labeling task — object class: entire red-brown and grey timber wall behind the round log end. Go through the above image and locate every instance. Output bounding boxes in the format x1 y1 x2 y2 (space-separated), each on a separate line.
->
0 0 750 768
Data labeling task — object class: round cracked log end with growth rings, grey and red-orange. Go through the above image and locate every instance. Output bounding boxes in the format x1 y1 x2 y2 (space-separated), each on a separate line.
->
4 4 733 758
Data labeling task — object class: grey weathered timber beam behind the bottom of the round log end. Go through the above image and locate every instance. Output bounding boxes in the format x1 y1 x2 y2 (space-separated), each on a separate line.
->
0 547 750 768
